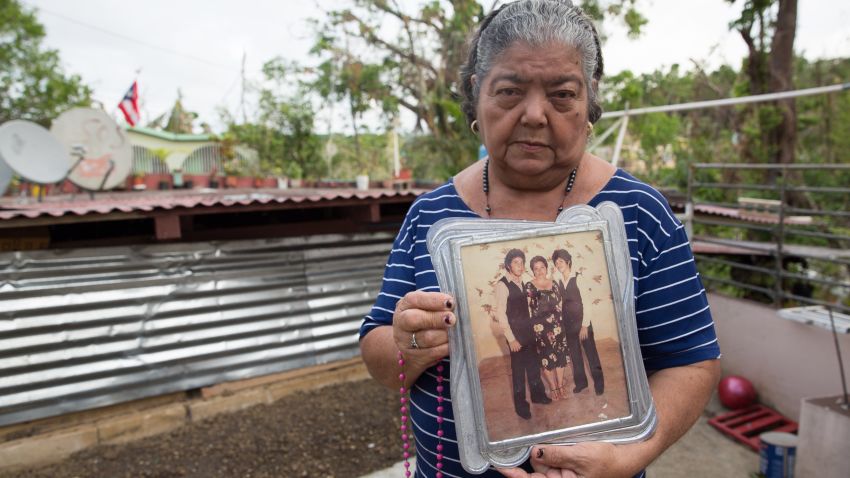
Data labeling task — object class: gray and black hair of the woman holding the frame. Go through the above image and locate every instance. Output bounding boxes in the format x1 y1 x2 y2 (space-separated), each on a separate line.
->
460 0 603 124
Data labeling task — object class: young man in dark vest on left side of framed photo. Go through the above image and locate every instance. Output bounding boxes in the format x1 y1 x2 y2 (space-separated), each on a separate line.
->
496 249 552 420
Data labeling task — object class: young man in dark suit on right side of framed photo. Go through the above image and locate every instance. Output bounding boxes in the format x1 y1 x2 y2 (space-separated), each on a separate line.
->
552 249 605 395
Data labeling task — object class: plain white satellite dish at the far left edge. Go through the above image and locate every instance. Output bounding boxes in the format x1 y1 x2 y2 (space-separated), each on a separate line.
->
0 120 71 193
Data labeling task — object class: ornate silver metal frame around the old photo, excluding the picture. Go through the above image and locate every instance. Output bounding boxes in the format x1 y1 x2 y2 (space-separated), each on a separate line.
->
427 202 657 474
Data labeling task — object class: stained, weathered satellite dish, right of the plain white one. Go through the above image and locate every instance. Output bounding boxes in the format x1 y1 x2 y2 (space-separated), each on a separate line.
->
50 108 133 191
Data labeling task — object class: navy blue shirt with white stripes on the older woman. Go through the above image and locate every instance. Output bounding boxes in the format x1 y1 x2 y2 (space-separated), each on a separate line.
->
360 169 720 477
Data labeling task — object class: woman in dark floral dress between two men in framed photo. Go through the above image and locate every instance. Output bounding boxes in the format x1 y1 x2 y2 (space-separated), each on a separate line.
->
525 256 566 400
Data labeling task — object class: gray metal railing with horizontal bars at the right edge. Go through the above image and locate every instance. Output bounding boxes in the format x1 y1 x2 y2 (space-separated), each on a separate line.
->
683 163 850 313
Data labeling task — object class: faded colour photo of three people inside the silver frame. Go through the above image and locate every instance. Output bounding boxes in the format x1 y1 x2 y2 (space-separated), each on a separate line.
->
460 230 631 441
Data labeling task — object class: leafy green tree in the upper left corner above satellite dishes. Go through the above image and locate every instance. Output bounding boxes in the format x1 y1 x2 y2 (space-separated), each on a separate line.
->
0 0 91 126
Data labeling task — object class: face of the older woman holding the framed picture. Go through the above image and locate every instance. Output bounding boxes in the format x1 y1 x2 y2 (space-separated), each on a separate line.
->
474 43 588 179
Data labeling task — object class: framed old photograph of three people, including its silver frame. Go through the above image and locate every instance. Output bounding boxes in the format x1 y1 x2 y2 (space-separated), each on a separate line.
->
428 203 656 473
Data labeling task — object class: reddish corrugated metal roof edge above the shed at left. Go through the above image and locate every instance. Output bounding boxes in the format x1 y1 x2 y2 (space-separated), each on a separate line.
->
0 189 425 221
